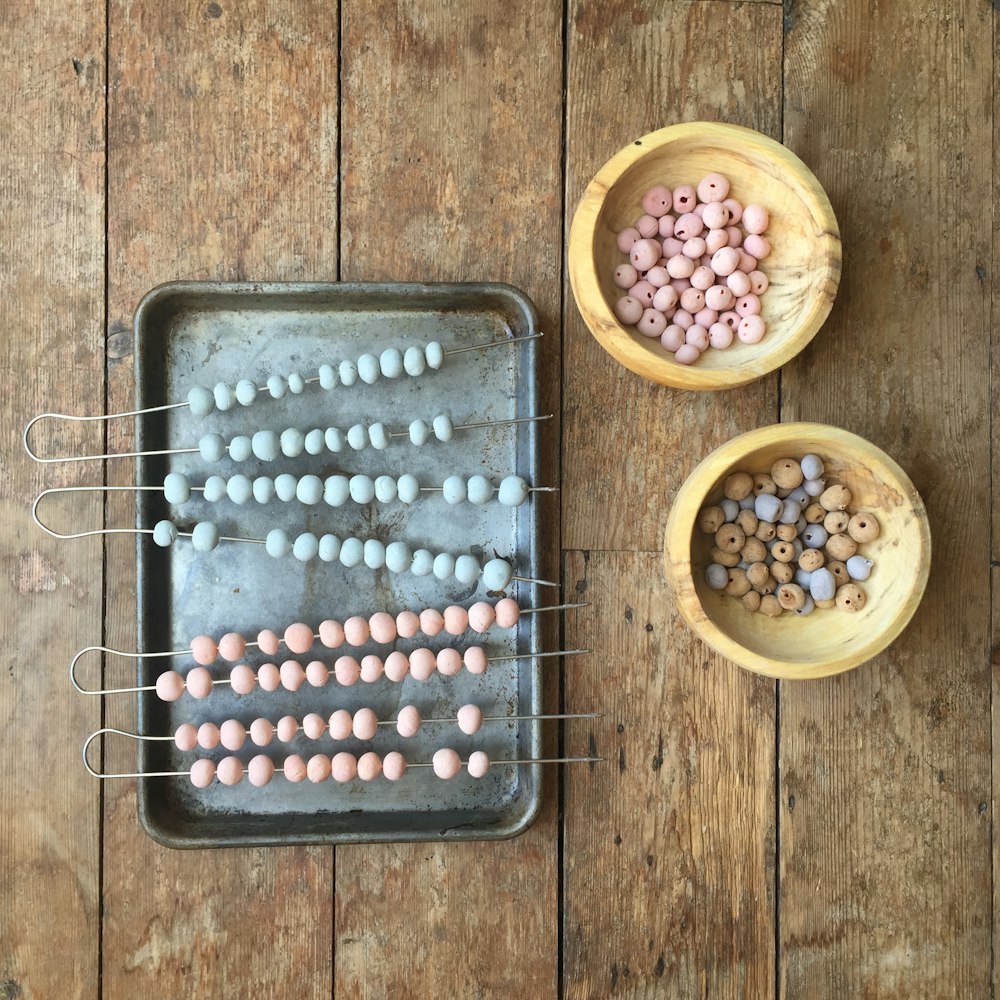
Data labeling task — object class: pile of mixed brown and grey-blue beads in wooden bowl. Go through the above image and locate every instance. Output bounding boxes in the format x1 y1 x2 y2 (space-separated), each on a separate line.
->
698 455 881 618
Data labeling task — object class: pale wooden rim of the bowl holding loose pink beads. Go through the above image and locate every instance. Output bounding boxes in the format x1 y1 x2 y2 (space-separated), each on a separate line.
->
567 121 841 390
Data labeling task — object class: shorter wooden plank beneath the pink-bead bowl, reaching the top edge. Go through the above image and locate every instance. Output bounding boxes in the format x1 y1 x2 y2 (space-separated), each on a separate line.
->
563 0 781 551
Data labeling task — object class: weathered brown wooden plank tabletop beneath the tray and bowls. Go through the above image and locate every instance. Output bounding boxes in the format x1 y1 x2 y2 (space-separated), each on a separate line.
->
0 0 1000 1000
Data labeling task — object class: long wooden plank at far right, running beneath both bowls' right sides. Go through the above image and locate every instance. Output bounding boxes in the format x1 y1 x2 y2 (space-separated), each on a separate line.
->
779 2 994 998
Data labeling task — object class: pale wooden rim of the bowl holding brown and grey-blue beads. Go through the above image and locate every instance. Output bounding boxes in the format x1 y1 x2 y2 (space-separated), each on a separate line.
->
663 421 931 680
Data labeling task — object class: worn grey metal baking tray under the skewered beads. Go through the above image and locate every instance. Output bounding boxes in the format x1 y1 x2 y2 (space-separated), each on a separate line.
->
135 282 557 848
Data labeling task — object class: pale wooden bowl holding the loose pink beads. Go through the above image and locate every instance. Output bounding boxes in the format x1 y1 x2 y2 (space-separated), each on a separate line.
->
569 122 840 389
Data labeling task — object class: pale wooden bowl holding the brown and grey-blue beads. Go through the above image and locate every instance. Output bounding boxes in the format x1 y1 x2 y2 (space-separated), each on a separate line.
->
664 423 931 679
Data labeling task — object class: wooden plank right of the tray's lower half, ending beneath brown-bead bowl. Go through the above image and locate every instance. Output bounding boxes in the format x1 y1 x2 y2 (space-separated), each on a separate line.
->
563 552 775 998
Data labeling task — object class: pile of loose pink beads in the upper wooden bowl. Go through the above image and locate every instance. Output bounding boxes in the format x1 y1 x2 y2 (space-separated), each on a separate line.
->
614 174 771 365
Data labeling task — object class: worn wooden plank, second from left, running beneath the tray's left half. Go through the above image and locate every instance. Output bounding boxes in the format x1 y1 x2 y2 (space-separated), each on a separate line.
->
104 0 338 997
